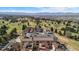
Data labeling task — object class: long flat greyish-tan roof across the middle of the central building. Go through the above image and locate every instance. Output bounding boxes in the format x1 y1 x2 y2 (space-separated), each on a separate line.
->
22 33 53 41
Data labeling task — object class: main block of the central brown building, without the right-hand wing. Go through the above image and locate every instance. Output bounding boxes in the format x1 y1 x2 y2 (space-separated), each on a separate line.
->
22 28 54 51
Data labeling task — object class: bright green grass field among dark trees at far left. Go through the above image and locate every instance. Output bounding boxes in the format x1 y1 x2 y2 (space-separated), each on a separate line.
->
0 20 22 34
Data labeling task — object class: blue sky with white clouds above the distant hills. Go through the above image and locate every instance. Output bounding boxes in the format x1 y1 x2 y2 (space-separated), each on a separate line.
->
0 7 79 13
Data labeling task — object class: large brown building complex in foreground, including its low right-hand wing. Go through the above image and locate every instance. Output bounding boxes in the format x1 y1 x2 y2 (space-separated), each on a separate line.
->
22 27 65 51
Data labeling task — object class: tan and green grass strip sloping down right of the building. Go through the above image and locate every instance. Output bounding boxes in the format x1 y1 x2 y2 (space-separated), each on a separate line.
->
55 34 79 51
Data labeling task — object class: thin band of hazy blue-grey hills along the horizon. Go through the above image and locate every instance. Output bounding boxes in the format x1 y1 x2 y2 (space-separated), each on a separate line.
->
0 12 79 16
